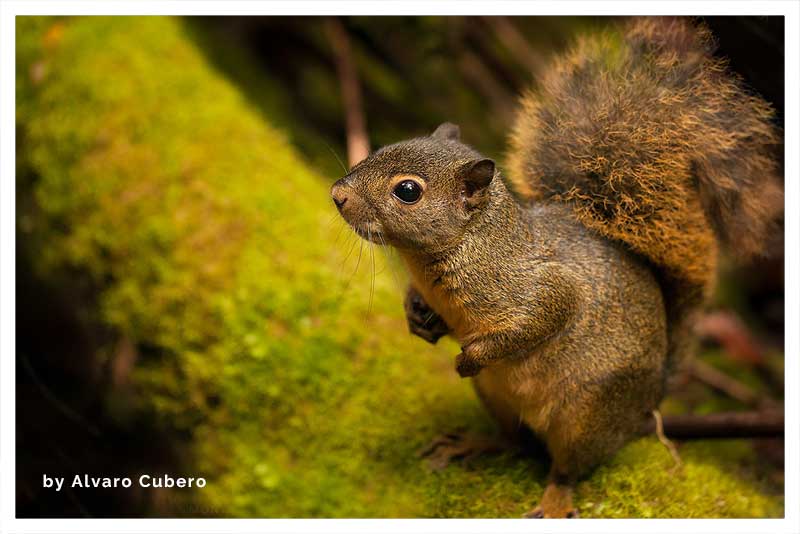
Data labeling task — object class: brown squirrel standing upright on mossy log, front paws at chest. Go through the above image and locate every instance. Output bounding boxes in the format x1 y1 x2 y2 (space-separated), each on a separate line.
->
331 17 783 517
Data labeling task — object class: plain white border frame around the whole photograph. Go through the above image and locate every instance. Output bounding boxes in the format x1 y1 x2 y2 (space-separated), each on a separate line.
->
0 0 800 534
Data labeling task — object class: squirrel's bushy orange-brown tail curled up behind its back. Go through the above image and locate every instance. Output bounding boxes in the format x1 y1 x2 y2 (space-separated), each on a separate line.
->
509 17 783 370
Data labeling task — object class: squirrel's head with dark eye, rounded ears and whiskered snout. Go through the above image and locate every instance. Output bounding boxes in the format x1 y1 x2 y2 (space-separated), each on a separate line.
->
331 123 495 251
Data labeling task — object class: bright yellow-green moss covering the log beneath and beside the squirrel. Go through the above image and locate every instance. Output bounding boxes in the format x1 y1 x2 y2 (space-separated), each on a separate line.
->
17 17 783 517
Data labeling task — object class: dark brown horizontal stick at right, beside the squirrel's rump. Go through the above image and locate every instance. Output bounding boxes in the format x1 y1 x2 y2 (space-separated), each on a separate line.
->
646 410 783 440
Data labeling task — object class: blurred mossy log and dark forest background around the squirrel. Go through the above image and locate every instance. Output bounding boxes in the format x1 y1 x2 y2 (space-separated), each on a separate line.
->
16 17 784 517
